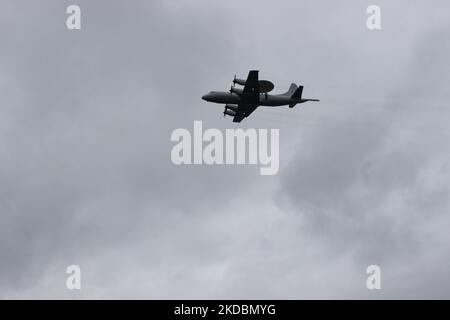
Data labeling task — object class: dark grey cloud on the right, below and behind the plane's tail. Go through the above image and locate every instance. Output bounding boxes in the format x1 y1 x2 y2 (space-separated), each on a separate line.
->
279 22 450 298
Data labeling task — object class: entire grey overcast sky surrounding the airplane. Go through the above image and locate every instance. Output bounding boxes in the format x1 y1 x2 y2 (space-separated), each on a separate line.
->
0 0 450 299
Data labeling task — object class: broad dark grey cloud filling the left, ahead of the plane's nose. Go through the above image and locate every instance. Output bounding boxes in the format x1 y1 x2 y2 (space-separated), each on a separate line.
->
1 1 253 296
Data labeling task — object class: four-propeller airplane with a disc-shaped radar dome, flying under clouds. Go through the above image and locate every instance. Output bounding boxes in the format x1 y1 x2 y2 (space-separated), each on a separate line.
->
202 70 320 122
